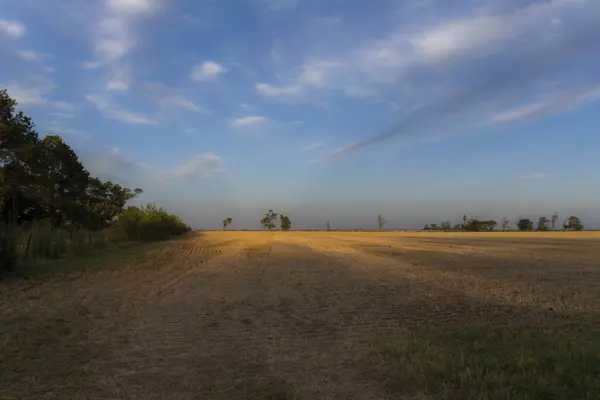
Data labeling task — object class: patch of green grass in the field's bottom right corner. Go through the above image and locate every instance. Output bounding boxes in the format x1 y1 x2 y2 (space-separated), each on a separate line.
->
380 326 600 400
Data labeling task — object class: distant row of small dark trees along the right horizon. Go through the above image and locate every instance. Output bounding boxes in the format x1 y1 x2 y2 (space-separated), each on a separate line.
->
423 213 584 232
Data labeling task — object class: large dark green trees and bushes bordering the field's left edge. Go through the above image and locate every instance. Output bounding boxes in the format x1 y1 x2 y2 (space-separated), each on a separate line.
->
0 90 190 276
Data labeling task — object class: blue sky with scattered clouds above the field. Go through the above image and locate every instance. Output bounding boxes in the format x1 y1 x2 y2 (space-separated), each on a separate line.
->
0 0 600 229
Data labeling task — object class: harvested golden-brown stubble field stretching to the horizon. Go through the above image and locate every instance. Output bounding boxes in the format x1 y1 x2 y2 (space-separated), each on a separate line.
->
0 232 600 400
